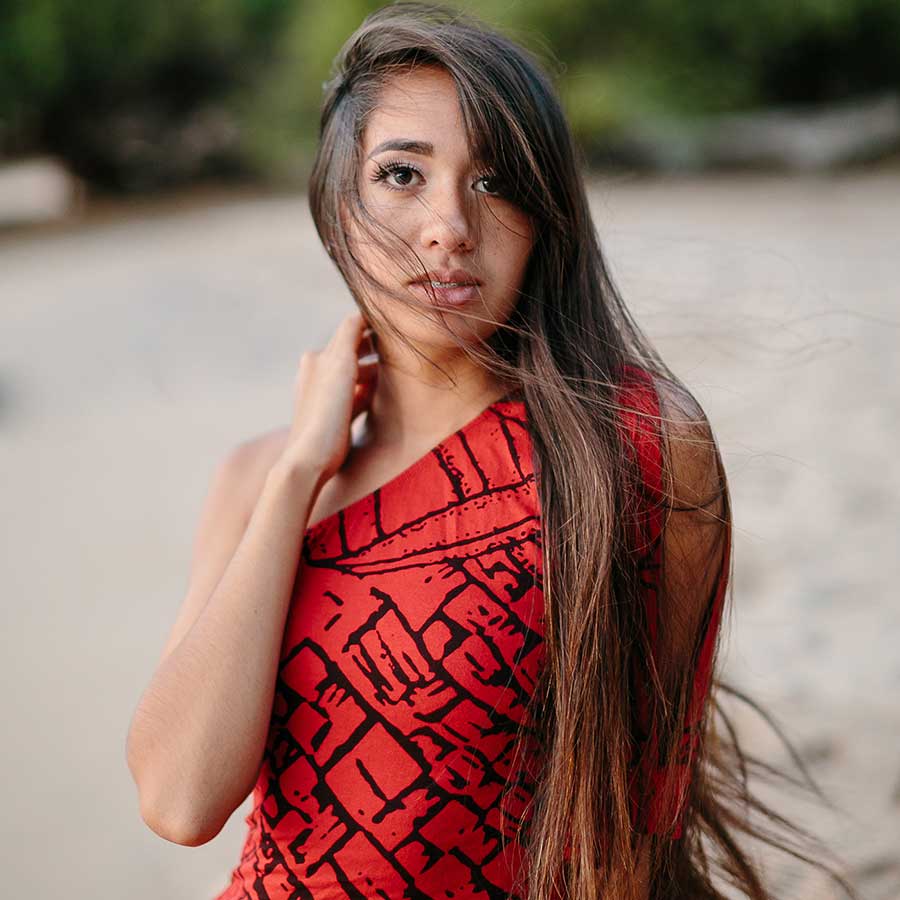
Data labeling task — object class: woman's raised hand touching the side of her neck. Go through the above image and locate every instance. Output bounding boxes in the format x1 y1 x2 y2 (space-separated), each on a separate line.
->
280 312 378 484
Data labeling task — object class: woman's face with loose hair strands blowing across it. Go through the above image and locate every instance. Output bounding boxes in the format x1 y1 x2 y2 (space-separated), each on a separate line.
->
351 67 534 347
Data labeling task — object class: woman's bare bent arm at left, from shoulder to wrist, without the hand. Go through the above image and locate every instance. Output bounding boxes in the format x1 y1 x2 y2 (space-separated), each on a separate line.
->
127 441 321 846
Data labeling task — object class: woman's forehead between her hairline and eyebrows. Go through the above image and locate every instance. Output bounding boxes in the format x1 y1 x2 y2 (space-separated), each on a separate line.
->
362 66 469 156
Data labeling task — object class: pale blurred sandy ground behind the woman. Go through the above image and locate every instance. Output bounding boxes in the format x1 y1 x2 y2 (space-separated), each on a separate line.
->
0 172 900 900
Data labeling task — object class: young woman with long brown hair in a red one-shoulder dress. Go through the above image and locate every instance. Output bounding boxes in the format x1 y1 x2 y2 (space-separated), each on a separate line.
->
128 3 856 900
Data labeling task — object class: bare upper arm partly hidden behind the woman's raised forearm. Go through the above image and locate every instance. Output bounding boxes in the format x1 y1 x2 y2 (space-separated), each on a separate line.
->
160 430 283 662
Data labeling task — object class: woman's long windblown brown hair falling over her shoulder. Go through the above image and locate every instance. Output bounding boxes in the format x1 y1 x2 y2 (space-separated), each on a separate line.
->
309 3 855 900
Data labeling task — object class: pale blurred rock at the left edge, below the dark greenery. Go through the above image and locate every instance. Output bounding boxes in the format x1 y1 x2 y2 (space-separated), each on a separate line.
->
0 157 84 228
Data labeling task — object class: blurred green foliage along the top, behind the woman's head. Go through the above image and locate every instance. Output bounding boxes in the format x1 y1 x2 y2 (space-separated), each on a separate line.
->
0 0 900 183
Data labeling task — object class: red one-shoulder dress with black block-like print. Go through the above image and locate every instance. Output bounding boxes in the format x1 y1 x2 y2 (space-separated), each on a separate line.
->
216 369 718 900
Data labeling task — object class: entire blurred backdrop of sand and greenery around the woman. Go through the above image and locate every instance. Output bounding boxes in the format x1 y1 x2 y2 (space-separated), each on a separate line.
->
0 0 900 900
